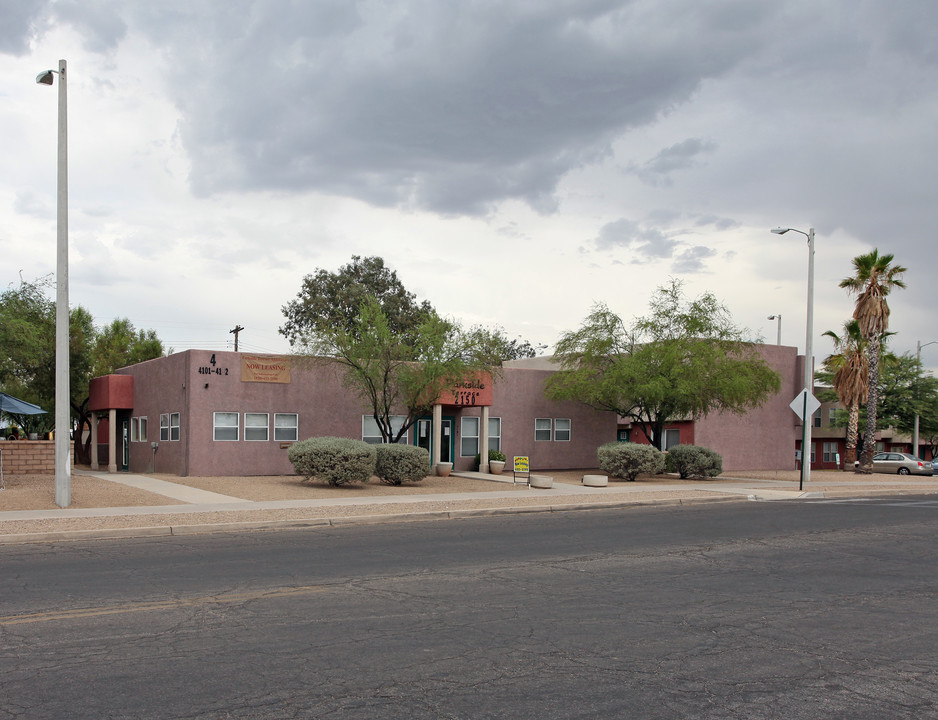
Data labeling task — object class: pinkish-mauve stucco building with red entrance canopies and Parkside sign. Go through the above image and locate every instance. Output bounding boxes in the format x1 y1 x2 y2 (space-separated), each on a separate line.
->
90 345 803 476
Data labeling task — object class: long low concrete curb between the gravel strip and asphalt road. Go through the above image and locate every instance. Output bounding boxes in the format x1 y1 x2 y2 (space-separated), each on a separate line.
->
0 495 752 545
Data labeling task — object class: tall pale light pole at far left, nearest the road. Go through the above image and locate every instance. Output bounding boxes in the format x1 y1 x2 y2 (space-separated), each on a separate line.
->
36 60 72 507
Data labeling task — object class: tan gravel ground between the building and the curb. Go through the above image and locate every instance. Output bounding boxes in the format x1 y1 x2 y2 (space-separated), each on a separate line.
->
0 468 938 536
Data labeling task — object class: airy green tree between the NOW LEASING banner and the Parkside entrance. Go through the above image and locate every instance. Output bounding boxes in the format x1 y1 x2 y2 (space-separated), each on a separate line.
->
304 296 501 442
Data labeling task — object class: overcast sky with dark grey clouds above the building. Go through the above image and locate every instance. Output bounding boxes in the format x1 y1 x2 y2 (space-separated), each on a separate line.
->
0 0 938 376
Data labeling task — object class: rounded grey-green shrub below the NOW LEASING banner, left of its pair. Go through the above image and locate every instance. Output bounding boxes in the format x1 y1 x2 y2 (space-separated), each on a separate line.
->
287 437 376 485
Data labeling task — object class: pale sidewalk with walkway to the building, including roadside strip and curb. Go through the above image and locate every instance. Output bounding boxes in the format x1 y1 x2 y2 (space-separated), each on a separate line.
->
0 471 938 543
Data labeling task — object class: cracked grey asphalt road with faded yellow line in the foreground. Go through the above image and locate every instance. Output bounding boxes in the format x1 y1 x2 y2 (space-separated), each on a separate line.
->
0 496 938 720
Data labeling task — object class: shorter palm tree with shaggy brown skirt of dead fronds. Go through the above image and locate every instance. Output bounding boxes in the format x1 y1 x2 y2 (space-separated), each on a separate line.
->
824 320 869 470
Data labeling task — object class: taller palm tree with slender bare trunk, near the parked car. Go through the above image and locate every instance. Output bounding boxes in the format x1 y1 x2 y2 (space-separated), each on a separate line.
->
840 249 906 473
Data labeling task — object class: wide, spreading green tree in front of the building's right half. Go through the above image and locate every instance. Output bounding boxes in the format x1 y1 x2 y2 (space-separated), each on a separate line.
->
546 280 781 449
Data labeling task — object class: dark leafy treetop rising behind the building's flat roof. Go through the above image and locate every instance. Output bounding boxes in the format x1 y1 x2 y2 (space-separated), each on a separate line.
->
280 255 434 346
